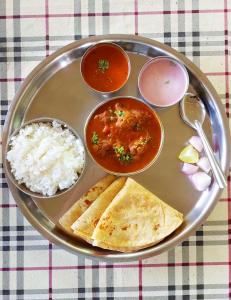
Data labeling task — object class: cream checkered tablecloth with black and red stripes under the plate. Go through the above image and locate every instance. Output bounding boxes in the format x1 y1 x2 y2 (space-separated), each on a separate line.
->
0 0 231 300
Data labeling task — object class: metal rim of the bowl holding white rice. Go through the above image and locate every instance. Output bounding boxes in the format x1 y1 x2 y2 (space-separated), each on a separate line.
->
4 117 86 199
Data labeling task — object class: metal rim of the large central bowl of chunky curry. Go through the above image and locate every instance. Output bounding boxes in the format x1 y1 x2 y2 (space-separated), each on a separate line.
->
84 96 165 176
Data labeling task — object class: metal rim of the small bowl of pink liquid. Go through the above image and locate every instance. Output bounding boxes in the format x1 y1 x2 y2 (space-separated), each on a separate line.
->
137 55 189 108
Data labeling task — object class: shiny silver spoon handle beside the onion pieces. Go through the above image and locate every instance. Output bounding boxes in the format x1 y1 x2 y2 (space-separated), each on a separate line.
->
195 120 227 189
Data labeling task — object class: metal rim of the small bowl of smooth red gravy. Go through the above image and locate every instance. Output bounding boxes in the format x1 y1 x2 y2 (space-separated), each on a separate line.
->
79 41 131 95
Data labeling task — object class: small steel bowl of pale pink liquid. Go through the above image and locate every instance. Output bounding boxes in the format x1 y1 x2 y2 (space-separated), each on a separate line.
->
138 56 189 107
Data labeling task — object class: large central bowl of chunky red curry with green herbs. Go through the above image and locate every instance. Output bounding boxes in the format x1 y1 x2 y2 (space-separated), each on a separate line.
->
84 97 164 175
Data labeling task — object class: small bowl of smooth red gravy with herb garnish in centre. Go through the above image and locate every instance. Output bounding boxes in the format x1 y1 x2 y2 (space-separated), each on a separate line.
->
80 42 130 93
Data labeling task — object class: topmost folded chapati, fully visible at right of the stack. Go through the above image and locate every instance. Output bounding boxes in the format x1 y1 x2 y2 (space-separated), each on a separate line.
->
91 178 183 252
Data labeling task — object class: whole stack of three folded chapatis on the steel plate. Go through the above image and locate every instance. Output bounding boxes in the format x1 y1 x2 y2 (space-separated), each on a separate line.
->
60 175 183 252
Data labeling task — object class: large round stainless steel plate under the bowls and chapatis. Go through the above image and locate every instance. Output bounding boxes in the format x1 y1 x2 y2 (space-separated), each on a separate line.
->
3 35 230 261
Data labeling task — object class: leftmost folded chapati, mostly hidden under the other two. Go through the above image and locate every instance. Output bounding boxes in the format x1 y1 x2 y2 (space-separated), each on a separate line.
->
59 175 116 233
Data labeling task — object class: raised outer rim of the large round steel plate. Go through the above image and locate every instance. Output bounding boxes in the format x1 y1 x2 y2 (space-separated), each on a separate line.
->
2 34 230 261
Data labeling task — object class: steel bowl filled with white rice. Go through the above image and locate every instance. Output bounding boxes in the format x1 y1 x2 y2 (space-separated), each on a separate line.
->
6 118 86 198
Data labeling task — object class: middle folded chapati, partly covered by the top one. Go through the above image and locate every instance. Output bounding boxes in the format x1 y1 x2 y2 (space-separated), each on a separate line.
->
71 177 126 243
